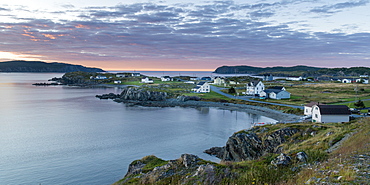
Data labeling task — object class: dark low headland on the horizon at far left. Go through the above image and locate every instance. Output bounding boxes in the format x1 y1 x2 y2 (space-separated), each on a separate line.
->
0 60 105 73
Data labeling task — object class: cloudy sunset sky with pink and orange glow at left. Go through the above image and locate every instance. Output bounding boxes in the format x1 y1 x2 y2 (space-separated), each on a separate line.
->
0 0 370 71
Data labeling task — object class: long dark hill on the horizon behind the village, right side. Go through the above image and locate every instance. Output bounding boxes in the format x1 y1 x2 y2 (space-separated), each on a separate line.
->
214 65 370 77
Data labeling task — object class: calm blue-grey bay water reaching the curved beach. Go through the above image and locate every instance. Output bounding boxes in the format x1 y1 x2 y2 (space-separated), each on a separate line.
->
0 73 274 185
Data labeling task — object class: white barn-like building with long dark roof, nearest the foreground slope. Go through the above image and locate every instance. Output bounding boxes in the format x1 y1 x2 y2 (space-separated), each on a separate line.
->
312 105 351 123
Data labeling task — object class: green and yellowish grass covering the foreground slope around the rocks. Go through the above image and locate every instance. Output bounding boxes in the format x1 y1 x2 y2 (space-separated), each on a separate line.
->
116 118 370 185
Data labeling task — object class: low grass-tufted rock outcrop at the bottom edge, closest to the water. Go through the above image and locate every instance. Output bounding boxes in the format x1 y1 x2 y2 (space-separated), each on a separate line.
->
115 154 236 185
